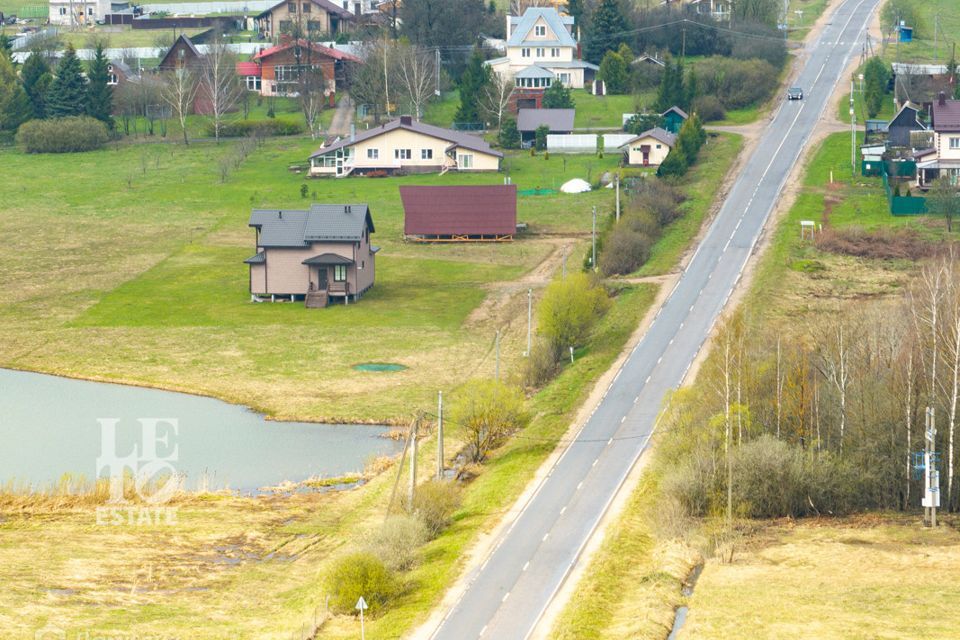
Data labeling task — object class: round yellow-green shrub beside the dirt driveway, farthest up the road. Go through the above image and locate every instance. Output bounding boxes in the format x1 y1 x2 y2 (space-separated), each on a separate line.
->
537 273 610 351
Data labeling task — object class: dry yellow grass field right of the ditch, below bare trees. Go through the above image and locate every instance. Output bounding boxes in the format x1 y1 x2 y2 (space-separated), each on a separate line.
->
680 515 960 639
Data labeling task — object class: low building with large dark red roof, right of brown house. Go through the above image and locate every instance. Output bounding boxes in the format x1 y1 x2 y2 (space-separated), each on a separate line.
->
400 189 517 242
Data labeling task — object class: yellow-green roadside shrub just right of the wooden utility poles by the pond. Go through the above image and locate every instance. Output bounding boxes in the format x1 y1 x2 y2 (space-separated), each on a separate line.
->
452 380 530 462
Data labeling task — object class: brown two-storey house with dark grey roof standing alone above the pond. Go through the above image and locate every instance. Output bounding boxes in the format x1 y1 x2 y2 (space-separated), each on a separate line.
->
244 204 380 307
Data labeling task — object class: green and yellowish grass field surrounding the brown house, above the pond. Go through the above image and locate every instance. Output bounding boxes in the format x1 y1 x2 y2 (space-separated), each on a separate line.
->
0 139 617 421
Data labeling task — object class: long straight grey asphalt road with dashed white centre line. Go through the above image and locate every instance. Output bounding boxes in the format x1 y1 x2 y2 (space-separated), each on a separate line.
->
432 0 879 640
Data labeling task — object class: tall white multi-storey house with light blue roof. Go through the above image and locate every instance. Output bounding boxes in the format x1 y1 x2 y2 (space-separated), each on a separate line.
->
486 7 598 89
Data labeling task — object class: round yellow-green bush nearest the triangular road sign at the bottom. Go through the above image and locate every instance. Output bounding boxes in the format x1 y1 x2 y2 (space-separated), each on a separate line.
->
326 551 400 616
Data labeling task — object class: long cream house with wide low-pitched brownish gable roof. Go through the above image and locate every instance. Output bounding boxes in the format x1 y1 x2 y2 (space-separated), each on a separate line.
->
310 116 503 178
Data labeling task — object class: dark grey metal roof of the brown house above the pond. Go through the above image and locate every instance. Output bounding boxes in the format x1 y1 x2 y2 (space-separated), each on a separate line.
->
249 204 375 247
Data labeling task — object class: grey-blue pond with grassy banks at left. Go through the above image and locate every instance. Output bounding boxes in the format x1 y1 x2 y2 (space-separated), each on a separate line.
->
0 369 402 493
